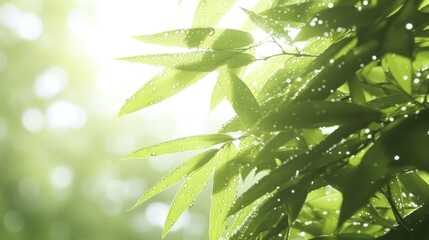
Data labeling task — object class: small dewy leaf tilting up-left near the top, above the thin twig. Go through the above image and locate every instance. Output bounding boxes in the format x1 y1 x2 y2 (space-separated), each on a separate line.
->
241 8 292 43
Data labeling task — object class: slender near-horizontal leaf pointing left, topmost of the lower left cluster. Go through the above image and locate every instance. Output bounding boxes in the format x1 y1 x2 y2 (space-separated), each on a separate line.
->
126 133 233 159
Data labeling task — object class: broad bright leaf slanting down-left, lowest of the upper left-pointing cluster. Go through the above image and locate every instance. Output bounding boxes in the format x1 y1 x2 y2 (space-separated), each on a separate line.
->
118 69 207 116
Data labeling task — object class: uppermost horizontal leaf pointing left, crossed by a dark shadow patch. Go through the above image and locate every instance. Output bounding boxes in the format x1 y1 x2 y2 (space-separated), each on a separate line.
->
135 28 253 50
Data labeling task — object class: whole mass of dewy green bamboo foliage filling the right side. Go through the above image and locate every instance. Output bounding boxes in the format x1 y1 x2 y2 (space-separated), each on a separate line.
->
120 0 429 239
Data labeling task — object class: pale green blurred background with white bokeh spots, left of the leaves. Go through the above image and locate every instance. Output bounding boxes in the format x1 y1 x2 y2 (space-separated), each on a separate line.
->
0 0 228 240
